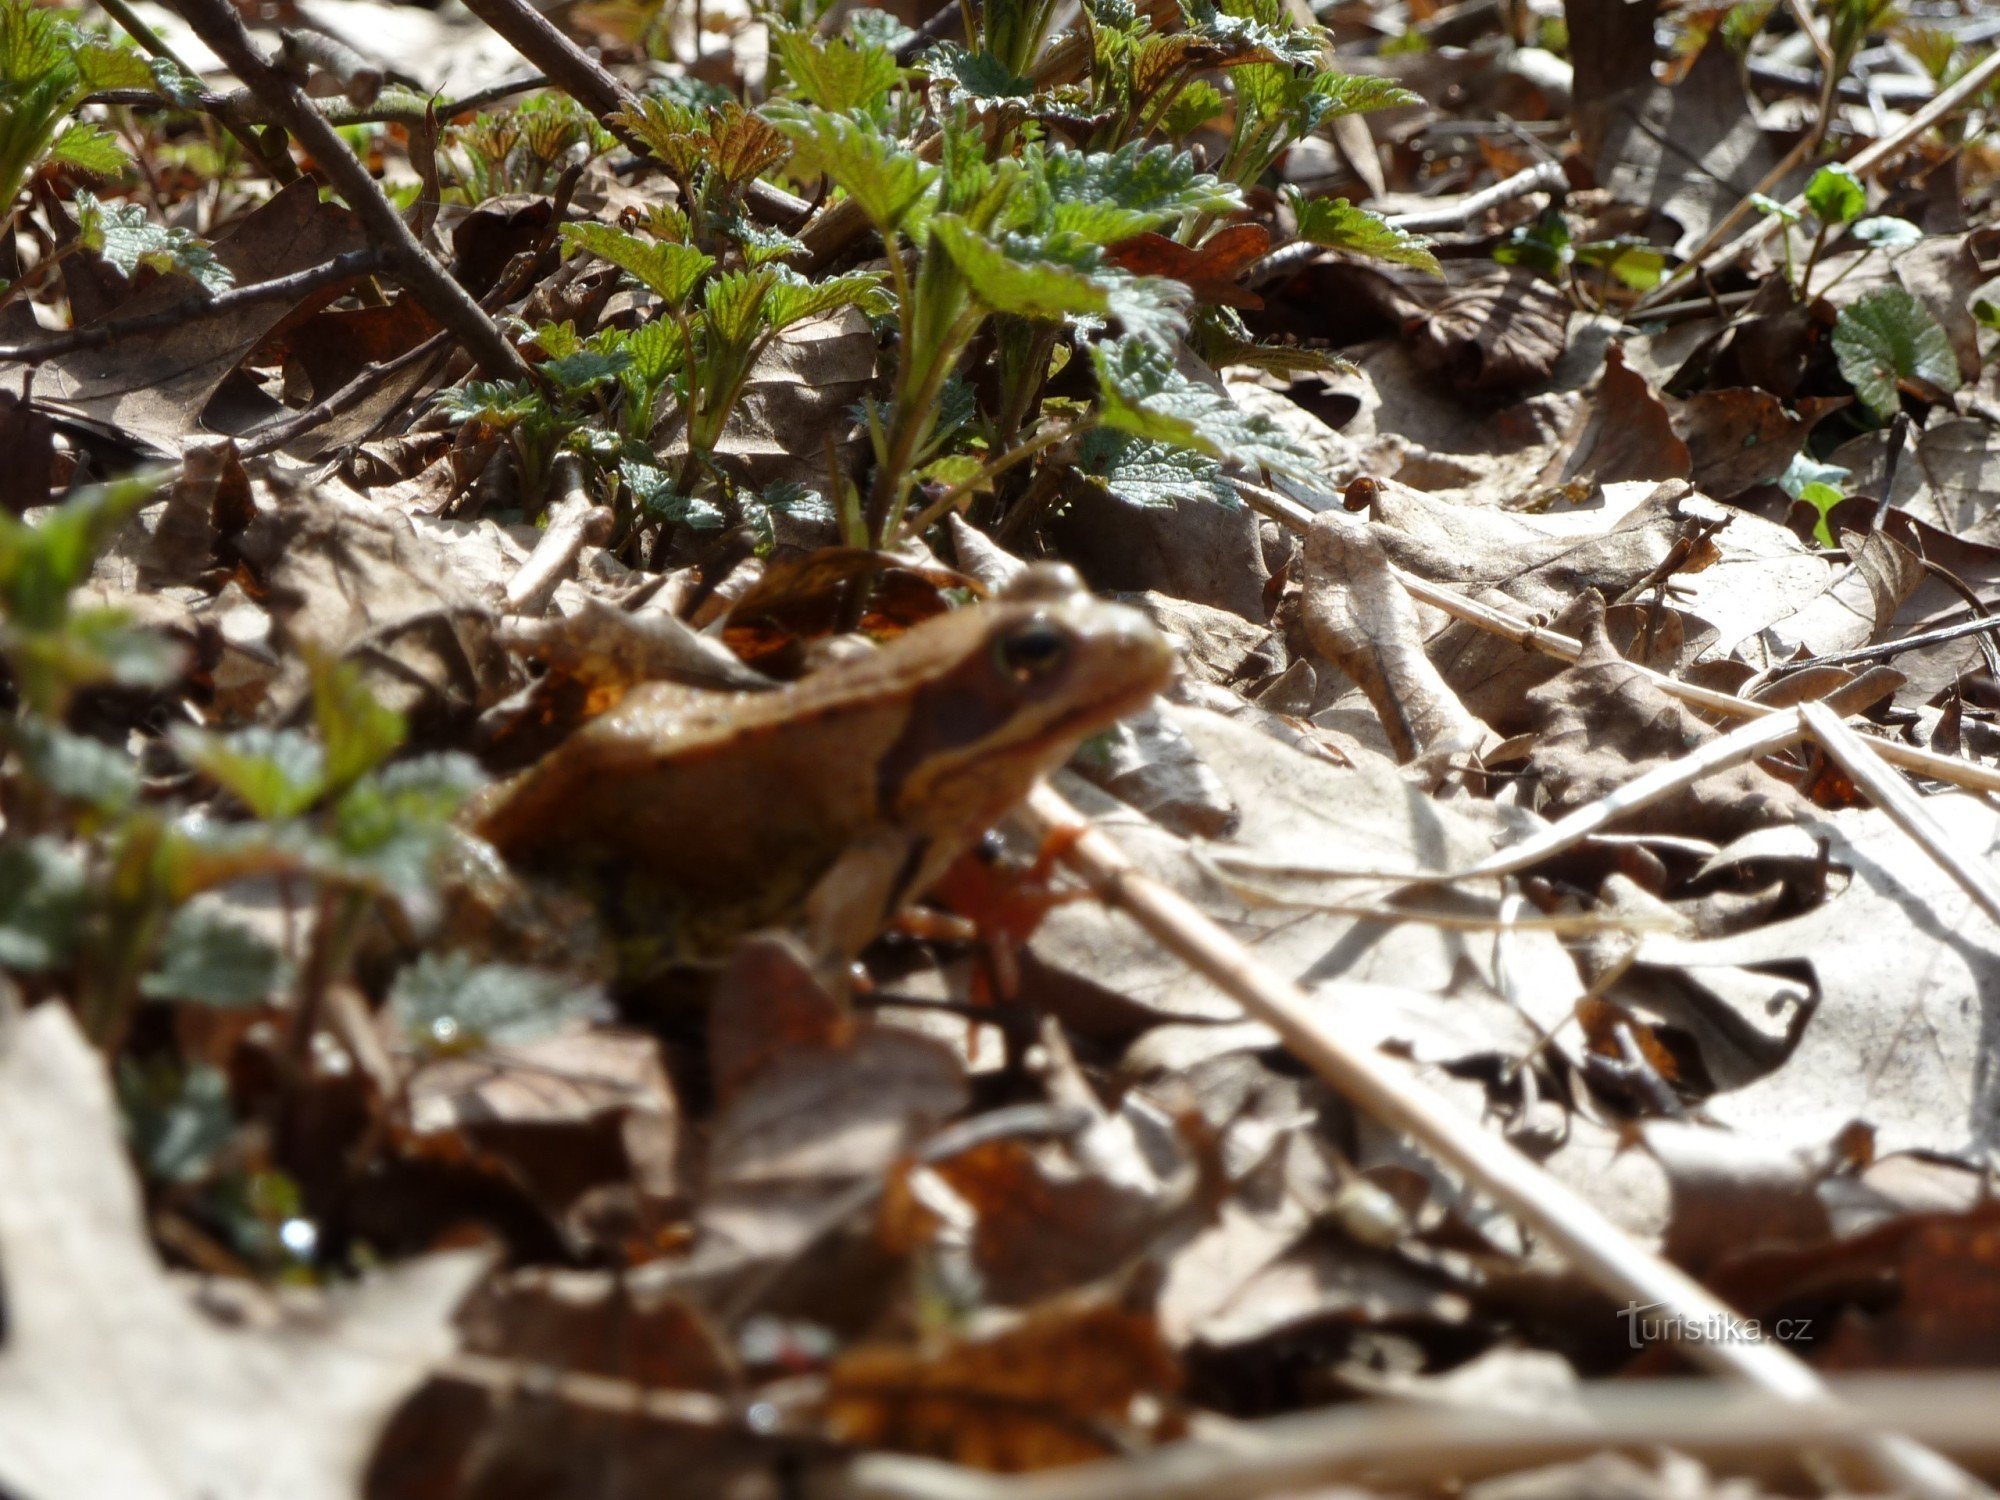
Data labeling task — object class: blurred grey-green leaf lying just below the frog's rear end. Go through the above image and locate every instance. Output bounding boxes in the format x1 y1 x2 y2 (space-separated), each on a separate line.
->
388 954 610 1052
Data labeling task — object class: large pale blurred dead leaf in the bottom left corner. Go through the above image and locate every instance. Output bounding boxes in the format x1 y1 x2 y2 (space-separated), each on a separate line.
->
0 1002 486 1500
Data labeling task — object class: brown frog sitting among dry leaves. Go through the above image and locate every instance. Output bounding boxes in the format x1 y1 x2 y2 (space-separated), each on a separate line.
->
464 564 1178 962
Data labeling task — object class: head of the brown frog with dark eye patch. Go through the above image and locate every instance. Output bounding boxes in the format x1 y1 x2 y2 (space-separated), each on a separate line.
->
878 568 1176 836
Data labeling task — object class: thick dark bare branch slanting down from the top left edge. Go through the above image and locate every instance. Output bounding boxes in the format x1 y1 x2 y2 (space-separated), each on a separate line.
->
178 0 532 380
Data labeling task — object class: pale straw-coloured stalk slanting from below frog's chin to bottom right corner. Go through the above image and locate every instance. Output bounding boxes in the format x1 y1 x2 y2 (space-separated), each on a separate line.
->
1020 788 1980 1496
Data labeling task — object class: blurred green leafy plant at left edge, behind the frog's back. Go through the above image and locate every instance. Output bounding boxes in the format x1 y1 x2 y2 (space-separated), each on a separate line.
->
0 480 480 1044
